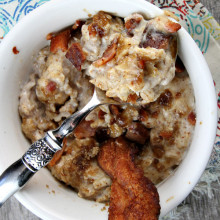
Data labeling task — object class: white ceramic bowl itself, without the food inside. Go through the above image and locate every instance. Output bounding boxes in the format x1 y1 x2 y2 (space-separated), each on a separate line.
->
0 0 217 220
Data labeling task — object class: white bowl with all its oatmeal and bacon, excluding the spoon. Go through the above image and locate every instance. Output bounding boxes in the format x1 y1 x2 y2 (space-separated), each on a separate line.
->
0 0 217 220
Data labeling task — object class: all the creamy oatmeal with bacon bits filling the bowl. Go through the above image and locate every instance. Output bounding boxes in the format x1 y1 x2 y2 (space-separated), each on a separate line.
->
19 12 196 202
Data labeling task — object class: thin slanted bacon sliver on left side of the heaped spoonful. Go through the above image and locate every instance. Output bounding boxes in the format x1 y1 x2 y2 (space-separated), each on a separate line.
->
93 38 118 67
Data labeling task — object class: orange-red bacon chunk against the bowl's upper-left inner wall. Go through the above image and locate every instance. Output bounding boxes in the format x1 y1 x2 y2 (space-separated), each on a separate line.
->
47 29 70 53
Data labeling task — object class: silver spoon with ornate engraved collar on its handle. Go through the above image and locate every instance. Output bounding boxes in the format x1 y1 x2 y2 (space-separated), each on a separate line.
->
0 89 124 207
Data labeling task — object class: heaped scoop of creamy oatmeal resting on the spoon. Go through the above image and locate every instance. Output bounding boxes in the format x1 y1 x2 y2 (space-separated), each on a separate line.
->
85 14 180 104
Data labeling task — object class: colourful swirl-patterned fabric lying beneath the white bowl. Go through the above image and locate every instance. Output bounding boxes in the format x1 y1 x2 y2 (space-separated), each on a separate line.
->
0 0 220 219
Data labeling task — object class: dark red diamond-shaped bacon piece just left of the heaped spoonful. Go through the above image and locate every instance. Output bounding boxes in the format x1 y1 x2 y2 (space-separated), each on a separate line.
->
66 43 86 71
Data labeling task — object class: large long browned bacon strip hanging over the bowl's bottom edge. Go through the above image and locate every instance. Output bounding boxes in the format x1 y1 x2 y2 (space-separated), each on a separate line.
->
98 137 160 220
